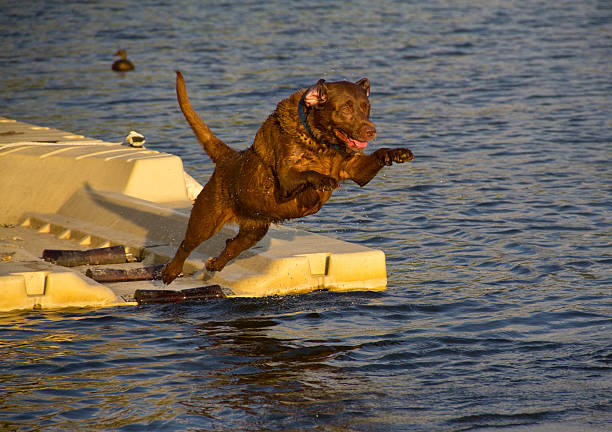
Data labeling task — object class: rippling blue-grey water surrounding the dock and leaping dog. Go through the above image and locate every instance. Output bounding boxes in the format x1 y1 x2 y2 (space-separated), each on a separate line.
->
0 0 612 431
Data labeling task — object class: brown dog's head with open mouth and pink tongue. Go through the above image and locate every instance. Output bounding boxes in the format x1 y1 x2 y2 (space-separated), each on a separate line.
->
302 78 376 152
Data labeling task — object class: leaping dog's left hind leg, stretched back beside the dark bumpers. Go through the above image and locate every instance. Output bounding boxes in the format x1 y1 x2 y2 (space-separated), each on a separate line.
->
162 175 233 284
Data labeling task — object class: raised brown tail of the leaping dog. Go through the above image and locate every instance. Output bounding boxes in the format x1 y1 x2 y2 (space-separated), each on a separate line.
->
176 71 236 162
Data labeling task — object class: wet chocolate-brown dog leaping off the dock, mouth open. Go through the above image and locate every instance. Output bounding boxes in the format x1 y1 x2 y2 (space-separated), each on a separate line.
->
163 71 413 284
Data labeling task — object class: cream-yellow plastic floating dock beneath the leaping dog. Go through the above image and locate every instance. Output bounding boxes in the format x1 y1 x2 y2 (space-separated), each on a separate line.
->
0 117 387 311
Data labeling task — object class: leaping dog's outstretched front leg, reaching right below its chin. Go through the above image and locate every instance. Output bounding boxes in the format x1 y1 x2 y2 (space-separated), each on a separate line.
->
341 148 414 187
